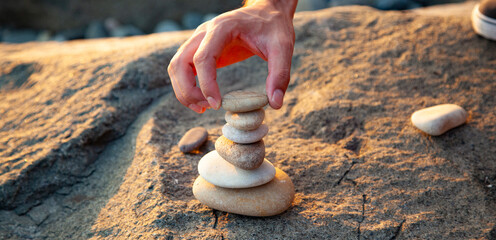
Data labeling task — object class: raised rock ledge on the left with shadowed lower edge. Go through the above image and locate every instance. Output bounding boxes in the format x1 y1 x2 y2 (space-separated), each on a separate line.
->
0 33 192 212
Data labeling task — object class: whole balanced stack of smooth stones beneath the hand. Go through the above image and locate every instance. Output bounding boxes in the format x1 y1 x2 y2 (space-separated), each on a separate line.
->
193 91 295 217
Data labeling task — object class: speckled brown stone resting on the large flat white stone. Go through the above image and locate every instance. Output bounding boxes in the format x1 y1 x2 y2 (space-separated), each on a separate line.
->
215 136 265 170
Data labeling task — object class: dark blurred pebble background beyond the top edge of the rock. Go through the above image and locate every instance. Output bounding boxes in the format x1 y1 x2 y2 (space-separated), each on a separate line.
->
0 0 463 43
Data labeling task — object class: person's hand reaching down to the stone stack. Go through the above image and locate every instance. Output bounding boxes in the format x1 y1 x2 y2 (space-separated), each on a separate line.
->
168 0 297 113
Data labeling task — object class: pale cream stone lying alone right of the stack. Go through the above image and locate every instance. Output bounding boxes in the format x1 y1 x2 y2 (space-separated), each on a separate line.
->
411 104 468 136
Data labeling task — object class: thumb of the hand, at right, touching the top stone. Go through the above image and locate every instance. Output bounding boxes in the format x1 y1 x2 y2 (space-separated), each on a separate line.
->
266 43 293 109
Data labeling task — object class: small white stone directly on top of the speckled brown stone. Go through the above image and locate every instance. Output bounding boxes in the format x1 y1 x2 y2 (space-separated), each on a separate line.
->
222 123 269 144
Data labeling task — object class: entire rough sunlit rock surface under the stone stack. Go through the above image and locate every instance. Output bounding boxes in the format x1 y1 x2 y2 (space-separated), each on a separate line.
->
0 2 496 239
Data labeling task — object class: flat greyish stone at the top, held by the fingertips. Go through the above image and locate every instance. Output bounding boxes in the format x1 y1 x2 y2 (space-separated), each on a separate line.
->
222 91 269 112
